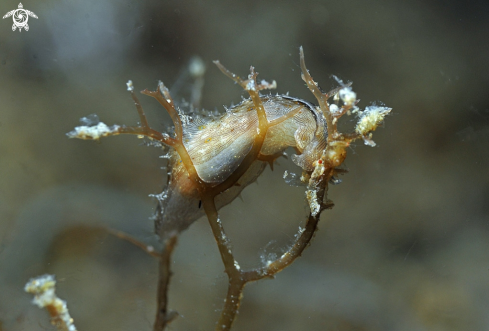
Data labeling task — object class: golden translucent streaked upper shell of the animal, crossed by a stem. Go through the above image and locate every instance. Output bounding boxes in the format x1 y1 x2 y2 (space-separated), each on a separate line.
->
179 96 325 184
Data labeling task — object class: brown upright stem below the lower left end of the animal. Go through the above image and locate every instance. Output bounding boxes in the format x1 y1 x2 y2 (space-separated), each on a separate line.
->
153 236 177 331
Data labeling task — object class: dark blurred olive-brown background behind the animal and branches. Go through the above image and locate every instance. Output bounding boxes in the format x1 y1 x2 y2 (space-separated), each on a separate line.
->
0 0 489 331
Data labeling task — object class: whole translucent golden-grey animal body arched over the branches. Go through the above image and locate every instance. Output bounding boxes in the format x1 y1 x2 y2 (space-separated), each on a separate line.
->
155 95 327 238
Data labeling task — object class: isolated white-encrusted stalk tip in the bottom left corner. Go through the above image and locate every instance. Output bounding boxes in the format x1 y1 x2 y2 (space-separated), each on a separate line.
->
24 275 76 331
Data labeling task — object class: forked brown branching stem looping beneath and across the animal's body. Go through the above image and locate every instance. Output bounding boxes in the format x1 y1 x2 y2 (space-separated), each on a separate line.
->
204 57 336 330
